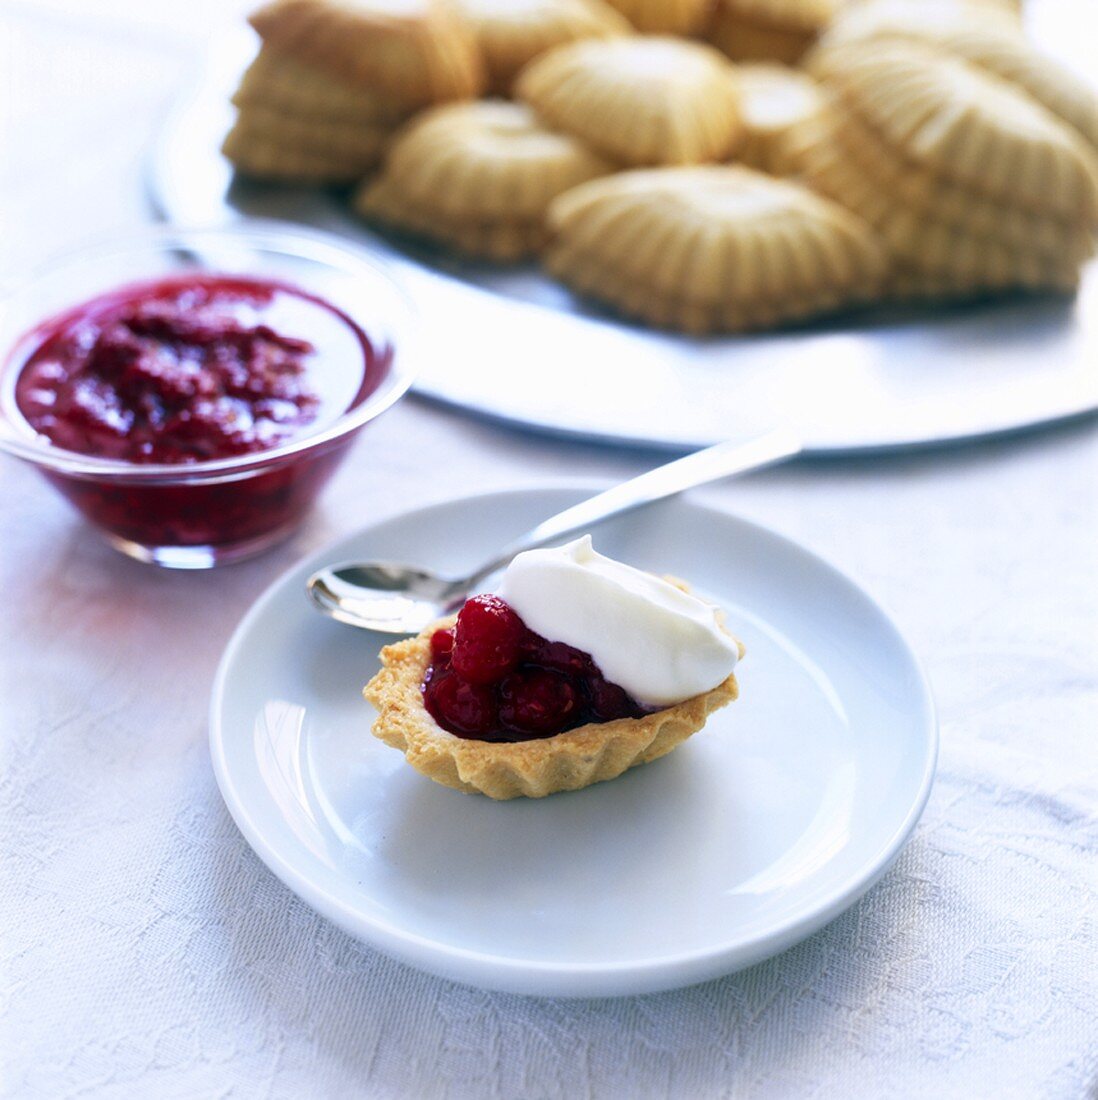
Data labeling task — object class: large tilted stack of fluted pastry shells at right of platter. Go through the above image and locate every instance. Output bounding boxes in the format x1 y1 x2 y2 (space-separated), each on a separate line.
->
792 40 1098 296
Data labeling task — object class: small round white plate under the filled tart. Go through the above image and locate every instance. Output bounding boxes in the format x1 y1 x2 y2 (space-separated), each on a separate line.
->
210 488 937 997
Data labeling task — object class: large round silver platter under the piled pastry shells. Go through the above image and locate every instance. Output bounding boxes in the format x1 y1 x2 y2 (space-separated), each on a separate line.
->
149 26 1098 455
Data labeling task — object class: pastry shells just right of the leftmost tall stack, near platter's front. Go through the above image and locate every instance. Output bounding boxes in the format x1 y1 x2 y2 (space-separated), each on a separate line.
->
354 100 613 261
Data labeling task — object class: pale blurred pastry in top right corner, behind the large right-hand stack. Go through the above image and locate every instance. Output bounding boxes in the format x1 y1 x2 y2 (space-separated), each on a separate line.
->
806 0 1098 147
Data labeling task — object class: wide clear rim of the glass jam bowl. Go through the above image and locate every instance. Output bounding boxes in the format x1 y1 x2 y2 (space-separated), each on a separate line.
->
0 218 417 483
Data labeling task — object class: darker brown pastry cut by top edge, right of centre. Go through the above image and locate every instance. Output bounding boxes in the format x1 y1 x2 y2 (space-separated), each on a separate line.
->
706 0 838 65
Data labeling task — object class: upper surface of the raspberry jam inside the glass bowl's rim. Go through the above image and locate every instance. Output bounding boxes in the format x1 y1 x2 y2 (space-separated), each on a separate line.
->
15 276 378 463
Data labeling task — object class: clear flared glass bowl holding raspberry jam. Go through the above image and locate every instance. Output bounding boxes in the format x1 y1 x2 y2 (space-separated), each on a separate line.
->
0 221 414 569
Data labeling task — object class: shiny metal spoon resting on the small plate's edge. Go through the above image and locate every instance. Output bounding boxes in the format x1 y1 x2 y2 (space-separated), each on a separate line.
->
306 429 801 635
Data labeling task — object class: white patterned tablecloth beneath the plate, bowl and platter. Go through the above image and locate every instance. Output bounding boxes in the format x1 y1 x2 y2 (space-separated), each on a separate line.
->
0 0 1098 1098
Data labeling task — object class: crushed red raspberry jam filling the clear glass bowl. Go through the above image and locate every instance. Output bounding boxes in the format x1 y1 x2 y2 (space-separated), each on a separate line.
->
6 273 394 568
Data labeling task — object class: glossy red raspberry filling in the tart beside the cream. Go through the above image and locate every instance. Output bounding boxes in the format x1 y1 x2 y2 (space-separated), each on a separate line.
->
422 595 648 741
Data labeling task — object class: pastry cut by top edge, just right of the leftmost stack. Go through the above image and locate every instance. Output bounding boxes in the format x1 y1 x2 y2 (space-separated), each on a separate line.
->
458 0 633 96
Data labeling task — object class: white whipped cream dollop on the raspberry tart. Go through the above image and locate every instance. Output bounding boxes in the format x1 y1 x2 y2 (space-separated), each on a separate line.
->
496 535 739 707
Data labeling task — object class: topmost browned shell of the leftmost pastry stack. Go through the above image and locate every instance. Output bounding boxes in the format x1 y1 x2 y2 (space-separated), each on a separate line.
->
249 0 485 106
